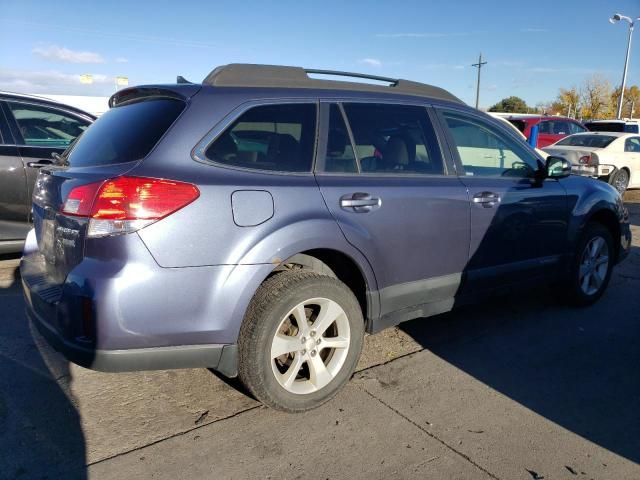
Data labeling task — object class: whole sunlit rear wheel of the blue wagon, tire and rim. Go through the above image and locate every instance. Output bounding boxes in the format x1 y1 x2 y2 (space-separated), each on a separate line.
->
238 271 364 412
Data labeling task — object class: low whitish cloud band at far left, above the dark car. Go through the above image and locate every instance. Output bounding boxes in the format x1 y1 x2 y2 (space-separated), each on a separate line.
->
0 68 114 95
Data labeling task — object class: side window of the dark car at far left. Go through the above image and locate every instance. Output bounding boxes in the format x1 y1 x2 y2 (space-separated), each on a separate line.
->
8 102 90 148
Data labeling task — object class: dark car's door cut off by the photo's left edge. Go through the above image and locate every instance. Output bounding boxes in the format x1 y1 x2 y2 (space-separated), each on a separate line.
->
0 102 28 242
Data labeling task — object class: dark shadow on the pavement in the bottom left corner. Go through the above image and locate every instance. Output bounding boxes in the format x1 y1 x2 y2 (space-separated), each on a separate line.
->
0 256 86 479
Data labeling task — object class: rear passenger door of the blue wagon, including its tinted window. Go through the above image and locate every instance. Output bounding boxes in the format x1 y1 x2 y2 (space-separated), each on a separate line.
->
316 102 469 324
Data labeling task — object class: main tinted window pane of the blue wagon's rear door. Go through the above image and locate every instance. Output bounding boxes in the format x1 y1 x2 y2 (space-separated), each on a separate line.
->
344 103 444 174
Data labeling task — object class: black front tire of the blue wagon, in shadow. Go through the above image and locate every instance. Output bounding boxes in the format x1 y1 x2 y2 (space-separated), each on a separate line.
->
569 222 615 307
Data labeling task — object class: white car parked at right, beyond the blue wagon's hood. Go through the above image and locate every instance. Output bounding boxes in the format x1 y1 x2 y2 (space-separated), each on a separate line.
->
543 132 640 194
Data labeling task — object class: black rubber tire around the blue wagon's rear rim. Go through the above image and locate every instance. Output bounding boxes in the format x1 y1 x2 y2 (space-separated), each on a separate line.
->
238 271 364 412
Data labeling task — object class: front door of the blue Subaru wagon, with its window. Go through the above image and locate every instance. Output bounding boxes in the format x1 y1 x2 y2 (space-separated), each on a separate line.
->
439 109 568 293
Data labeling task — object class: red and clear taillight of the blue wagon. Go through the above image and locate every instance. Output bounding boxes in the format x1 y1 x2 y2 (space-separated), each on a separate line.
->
62 177 200 237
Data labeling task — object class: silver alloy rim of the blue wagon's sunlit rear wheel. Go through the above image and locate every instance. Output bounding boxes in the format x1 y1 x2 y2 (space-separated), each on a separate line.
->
270 298 351 394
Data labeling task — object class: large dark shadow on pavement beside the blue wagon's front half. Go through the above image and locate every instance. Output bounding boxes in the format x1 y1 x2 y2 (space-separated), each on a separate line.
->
400 247 640 463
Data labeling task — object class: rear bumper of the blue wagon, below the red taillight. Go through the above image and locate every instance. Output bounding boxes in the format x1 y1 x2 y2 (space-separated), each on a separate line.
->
20 235 273 376
